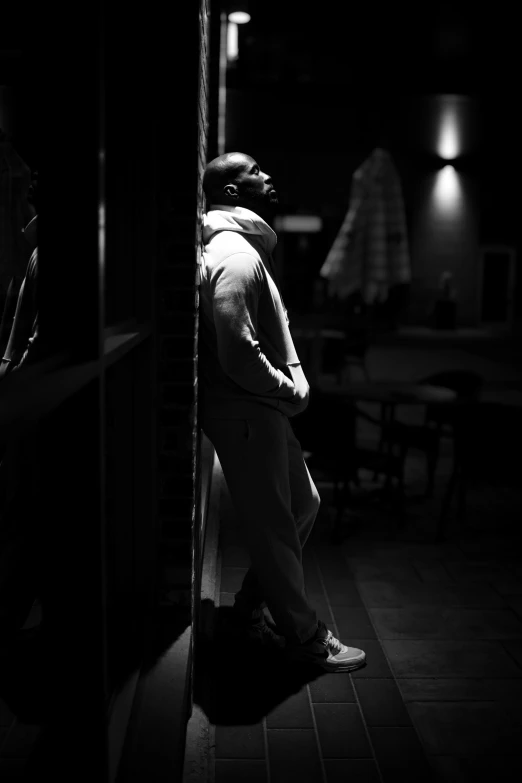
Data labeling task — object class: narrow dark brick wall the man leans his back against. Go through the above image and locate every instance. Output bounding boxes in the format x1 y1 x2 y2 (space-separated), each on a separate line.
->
158 0 210 605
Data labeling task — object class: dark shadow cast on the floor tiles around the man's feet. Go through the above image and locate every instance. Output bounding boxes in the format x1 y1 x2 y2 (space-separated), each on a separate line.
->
194 600 324 726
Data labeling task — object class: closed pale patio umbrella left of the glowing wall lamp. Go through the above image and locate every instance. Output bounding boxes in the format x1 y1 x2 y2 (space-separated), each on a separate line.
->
320 147 411 304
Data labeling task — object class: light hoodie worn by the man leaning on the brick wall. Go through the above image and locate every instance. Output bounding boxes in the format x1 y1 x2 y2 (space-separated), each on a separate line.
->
199 205 310 418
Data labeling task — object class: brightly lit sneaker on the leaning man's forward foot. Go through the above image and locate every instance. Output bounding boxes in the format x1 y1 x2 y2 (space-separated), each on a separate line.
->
286 620 366 672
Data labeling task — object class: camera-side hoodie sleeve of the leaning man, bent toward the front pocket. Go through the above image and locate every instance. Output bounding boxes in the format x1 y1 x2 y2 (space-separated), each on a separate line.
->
210 253 296 398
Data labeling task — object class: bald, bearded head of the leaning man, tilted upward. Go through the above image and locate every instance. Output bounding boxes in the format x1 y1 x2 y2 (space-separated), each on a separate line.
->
203 152 277 218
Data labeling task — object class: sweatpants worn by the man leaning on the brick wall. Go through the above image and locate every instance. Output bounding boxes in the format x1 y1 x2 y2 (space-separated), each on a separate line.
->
202 408 320 642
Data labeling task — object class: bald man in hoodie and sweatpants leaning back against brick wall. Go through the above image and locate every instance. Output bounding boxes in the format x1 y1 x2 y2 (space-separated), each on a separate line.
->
199 152 366 672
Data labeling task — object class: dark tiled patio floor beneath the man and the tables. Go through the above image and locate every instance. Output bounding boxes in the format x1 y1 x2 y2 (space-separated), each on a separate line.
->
207 450 522 783
